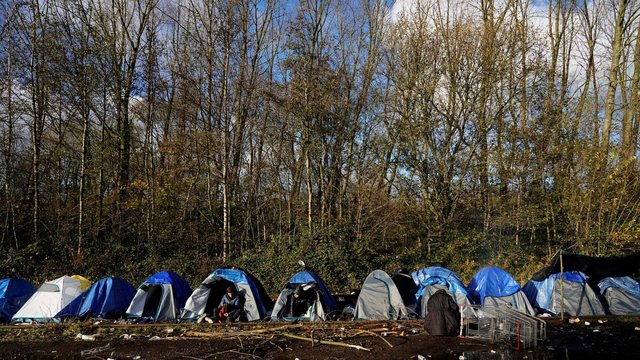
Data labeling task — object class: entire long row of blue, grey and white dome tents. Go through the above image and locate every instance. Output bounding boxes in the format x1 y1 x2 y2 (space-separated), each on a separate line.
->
0 253 640 323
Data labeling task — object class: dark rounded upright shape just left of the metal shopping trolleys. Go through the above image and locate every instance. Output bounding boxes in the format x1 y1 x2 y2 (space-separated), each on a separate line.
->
424 289 460 336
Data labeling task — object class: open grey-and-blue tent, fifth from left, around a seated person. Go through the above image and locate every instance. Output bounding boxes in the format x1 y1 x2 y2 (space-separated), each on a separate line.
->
180 268 272 321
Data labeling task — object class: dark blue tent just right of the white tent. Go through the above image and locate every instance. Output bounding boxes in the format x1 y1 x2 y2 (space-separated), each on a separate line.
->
56 277 136 319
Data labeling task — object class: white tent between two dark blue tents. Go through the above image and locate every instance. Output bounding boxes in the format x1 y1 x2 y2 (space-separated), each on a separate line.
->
11 275 91 323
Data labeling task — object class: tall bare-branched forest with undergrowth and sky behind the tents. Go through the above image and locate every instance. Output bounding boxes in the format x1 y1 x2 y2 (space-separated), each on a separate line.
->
0 0 640 291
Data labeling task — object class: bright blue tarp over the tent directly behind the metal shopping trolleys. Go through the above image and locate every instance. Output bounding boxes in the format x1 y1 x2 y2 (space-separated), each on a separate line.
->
467 266 521 305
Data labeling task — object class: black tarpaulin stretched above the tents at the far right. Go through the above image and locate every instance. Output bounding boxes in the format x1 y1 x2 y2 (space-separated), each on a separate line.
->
531 251 640 286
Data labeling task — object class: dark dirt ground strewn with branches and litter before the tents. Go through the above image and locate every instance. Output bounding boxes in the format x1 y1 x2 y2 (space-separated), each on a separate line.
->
0 317 640 360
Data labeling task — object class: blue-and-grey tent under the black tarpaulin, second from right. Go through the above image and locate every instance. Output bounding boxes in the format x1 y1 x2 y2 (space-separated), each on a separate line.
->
522 271 605 316
